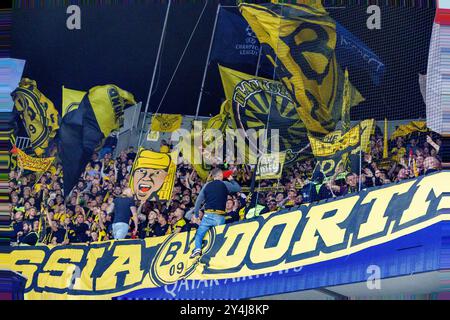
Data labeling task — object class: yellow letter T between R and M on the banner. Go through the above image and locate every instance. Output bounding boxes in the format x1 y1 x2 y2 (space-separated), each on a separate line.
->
358 181 415 239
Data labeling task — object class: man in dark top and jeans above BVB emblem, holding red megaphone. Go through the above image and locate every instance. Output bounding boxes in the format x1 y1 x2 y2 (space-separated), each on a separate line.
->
190 168 241 259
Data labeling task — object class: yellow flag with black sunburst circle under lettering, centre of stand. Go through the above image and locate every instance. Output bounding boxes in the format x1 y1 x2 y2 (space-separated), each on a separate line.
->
219 66 310 164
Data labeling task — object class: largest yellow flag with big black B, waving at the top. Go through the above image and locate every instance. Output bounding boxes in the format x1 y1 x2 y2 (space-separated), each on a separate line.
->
239 0 363 136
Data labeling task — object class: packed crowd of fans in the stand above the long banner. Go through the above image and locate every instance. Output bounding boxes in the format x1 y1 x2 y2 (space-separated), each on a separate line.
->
9 130 441 245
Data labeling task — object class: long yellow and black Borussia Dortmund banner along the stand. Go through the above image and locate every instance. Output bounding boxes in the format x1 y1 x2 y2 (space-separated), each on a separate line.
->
0 171 450 299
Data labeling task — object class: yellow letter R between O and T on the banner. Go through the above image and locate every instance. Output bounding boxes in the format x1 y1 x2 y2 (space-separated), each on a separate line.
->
292 196 359 255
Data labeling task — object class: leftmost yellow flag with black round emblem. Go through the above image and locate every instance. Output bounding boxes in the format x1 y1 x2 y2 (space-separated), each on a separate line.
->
11 78 59 156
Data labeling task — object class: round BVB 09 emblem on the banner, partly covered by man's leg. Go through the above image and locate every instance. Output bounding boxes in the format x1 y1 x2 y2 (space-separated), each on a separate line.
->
150 228 216 286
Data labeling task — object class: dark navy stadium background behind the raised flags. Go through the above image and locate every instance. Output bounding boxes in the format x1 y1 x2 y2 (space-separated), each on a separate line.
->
12 1 434 120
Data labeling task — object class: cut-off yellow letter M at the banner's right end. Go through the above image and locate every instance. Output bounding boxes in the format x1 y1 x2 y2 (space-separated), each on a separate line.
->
400 171 450 225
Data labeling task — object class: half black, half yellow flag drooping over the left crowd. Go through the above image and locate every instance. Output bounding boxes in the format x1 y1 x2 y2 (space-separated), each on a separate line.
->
58 84 136 197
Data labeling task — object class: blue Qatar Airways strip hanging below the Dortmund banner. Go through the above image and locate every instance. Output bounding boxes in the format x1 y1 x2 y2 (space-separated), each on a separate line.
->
113 222 450 300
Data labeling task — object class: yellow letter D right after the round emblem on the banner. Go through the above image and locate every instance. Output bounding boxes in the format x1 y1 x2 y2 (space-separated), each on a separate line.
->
209 221 259 269
